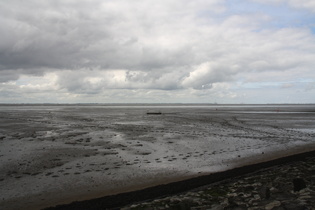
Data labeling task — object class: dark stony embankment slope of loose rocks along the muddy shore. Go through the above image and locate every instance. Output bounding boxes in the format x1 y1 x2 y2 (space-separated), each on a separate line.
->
121 157 315 210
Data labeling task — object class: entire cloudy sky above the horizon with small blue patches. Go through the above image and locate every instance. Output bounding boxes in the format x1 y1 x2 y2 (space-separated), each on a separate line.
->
0 0 315 103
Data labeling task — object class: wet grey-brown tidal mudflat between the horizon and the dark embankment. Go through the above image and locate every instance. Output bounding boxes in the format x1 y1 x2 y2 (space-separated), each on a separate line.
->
0 105 315 209
